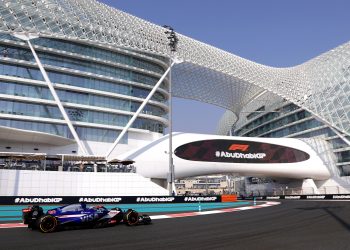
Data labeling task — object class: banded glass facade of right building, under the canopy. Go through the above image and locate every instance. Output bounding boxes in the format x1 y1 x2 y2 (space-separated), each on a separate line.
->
232 100 350 176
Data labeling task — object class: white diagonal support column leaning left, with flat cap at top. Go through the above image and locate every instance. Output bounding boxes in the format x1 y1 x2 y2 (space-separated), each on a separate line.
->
13 34 88 155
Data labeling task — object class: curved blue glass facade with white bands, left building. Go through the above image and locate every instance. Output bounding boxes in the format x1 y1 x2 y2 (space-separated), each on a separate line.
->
0 34 168 143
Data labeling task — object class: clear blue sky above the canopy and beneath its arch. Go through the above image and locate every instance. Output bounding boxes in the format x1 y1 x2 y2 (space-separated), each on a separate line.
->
101 0 350 134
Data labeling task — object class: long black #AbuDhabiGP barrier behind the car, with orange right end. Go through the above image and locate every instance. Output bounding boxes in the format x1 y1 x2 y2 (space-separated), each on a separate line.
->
0 195 237 205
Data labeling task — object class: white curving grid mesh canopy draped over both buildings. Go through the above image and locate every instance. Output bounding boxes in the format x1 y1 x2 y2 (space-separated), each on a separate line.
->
0 0 350 135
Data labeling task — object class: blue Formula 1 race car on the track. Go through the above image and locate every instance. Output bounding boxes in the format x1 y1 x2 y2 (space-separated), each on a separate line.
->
22 203 151 233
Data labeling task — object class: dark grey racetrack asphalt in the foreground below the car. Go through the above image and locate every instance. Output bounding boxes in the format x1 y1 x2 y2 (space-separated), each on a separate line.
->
0 201 350 250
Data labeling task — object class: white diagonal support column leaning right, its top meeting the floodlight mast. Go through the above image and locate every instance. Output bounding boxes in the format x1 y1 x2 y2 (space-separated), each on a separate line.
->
106 61 175 159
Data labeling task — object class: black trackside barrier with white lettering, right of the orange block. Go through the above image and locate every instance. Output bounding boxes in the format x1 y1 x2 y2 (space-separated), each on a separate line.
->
238 194 350 200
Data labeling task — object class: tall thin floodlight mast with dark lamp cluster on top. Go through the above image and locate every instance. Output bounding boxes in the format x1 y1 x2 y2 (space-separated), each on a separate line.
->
163 25 179 196
